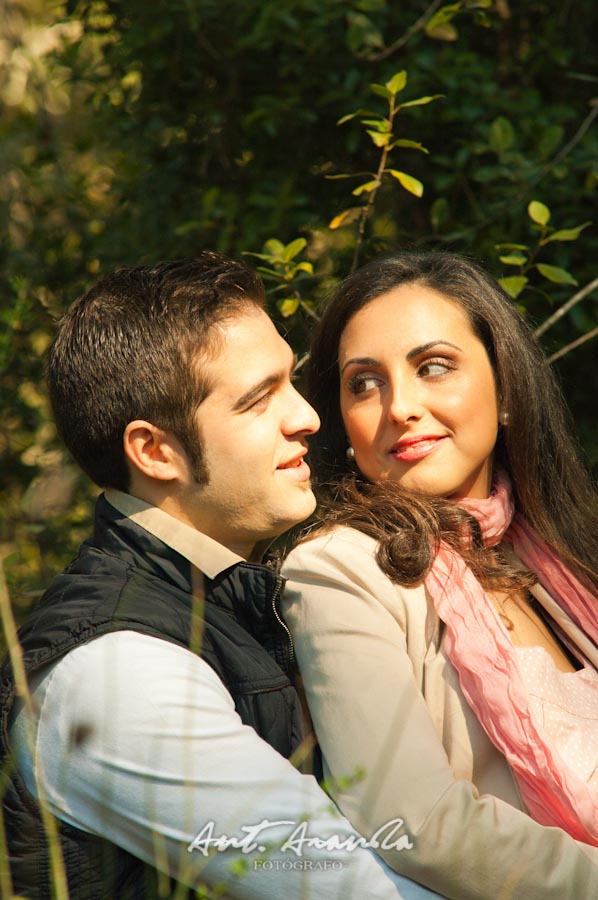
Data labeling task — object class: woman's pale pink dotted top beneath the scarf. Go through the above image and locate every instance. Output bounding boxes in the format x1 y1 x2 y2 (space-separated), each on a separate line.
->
515 647 598 792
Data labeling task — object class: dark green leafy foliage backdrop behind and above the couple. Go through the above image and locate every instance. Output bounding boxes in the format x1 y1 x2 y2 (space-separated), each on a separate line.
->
0 0 598 614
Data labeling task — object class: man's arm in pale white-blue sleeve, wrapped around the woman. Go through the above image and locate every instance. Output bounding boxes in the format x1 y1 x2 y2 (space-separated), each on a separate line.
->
8 632 437 900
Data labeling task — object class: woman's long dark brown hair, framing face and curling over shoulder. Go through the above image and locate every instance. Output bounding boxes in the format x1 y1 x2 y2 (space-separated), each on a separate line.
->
308 252 598 587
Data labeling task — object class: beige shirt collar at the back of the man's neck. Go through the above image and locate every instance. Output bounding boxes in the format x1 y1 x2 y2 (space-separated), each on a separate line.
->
104 488 245 578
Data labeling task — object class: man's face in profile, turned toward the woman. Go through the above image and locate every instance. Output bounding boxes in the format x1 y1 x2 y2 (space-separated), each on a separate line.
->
184 307 320 557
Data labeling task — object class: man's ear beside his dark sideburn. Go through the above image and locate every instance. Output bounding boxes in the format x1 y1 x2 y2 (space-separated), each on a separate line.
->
123 419 182 481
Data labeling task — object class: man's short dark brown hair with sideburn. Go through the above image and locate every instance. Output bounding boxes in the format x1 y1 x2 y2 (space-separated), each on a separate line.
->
46 251 265 490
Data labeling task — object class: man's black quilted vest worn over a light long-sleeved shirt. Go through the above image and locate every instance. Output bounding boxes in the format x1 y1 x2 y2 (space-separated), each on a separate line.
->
0 497 301 900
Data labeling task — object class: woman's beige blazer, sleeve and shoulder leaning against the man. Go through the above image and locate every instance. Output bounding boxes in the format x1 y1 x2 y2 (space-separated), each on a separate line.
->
283 527 598 900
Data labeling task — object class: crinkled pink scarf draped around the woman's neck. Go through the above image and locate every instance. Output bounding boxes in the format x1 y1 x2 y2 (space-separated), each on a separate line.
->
425 474 598 845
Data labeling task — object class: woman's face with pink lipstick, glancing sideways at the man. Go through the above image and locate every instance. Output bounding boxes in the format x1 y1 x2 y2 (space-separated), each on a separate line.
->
339 283 499 499
